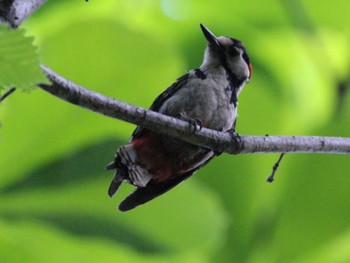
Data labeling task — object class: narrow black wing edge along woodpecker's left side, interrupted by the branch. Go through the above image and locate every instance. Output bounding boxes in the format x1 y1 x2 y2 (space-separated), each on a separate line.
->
129 73 190 142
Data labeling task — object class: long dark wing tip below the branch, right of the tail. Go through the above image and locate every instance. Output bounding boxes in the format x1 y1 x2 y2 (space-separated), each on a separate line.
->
119 153 215 212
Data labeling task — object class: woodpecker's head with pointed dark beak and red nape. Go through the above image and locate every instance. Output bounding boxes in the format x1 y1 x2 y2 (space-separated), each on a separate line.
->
200 24 252 81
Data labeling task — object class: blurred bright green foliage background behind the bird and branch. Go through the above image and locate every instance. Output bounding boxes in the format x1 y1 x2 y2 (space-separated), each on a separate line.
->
0 0 350 263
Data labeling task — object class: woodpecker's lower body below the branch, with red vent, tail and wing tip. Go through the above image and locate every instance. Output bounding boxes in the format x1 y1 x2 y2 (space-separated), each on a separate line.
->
108 131 214 211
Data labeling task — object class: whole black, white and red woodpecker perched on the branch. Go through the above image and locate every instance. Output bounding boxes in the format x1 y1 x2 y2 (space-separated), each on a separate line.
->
107 24 252 211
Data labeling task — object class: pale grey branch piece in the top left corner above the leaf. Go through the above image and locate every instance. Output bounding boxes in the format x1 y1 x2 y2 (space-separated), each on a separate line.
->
0 0 46 28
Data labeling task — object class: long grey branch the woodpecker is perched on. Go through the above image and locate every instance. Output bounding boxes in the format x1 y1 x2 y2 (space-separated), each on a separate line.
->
38 65 350 154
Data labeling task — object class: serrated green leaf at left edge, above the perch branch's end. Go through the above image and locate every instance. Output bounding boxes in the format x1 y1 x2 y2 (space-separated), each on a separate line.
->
0 25 46 94
